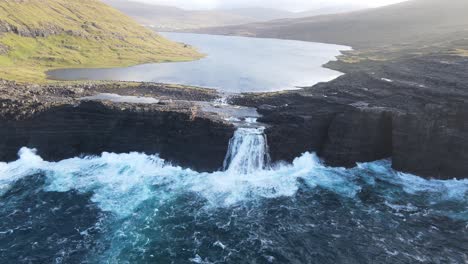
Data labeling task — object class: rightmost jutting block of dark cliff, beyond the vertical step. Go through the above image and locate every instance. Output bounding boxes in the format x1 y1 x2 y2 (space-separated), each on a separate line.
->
393 104 468 179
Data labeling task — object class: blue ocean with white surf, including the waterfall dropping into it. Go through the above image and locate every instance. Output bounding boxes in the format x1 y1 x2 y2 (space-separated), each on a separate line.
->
0 140 468 264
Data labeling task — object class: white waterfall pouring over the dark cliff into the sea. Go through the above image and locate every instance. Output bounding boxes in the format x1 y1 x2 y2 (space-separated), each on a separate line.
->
224 127 270 174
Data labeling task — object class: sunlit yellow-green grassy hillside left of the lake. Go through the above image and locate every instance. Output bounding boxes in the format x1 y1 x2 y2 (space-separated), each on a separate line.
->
0 0 201 82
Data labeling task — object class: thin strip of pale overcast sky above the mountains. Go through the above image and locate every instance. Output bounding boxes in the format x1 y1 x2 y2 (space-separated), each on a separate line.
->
133 0 404 11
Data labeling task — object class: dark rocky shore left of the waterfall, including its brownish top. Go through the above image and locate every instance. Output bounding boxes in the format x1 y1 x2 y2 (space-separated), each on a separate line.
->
0 81 234 171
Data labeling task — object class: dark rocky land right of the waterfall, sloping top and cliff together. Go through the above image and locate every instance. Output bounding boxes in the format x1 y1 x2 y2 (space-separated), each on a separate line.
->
233 55 468 179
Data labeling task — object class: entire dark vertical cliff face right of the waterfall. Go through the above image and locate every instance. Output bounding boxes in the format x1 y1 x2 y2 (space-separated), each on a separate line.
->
249 98 468 179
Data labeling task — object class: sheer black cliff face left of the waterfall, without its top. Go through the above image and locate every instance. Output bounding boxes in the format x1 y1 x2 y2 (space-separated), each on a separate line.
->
0 102 234 171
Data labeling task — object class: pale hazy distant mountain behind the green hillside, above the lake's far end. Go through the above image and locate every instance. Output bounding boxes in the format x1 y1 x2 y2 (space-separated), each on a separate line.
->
103 0 257 31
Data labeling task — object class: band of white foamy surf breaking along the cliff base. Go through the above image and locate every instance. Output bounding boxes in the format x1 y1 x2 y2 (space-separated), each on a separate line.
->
0 148 468 219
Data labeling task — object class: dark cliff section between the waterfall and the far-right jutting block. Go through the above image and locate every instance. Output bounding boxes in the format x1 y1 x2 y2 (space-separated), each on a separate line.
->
247 95 393 167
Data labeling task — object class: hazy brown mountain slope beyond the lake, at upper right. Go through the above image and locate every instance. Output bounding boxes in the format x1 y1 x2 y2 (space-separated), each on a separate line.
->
198 0 468 47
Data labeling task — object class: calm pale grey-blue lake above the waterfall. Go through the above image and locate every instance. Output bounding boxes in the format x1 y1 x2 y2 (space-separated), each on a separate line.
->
49 33 350 92
